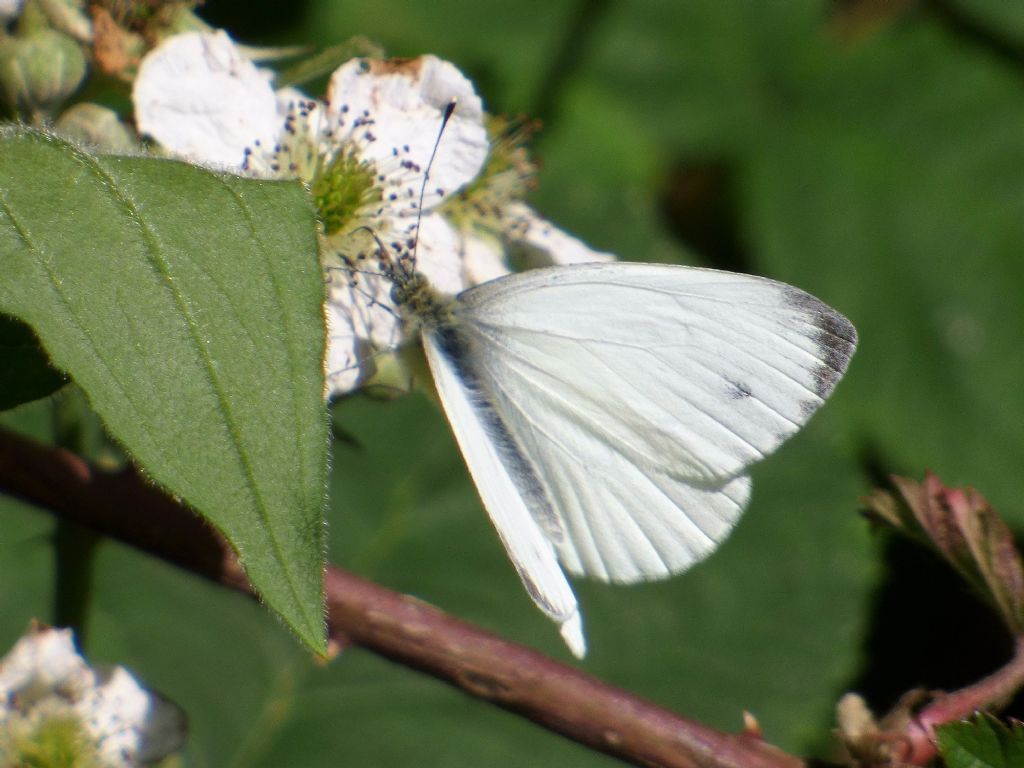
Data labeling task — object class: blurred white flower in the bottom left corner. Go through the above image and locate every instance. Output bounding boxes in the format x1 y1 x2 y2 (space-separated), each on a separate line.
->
0 629 185 768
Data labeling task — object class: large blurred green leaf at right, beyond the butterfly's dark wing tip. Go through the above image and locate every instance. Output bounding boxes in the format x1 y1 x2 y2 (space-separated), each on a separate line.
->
745 24 1024 525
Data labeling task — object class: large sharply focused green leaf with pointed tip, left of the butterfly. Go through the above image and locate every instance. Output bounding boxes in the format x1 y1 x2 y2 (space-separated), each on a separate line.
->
0 129 328 651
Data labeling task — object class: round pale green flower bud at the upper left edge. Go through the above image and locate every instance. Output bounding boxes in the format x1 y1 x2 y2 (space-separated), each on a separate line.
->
0 30 85 115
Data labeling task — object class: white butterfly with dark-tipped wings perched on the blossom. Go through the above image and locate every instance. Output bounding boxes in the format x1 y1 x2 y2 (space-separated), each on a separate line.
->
385 259 857 656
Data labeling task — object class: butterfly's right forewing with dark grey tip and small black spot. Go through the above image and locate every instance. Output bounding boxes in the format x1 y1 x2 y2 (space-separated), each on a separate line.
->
457 263 856 484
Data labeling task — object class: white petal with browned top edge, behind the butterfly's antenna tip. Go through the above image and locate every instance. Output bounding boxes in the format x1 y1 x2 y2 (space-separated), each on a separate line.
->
328 56 488 208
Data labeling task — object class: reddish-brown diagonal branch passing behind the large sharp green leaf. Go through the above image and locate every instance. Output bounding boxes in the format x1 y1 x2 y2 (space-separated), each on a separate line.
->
0 429 804 768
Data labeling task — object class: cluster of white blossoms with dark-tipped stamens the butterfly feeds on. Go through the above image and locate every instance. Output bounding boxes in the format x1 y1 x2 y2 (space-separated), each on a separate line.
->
126 32 612 396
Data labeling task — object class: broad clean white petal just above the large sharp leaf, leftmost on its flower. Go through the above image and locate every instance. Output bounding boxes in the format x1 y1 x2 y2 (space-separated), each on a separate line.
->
132 32 281 168
